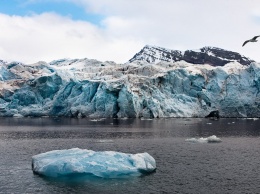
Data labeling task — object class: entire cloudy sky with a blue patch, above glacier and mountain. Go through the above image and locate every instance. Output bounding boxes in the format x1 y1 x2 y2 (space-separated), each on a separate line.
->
0 0 260 63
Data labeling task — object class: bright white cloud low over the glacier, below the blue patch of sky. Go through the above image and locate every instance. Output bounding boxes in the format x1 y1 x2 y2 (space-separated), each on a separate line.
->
0 13 141 63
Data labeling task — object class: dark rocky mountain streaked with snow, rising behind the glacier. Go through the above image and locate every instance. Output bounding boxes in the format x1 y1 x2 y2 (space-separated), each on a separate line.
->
129 45 254 66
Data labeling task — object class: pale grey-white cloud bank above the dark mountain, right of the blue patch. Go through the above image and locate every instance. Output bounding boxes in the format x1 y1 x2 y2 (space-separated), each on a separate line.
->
73 0 260 61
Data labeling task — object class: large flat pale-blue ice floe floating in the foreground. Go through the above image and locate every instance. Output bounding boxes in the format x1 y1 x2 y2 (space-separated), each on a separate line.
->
32 148 156 178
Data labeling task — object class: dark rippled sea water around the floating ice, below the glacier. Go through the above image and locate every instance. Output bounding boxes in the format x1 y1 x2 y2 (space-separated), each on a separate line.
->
0 118 260 194
